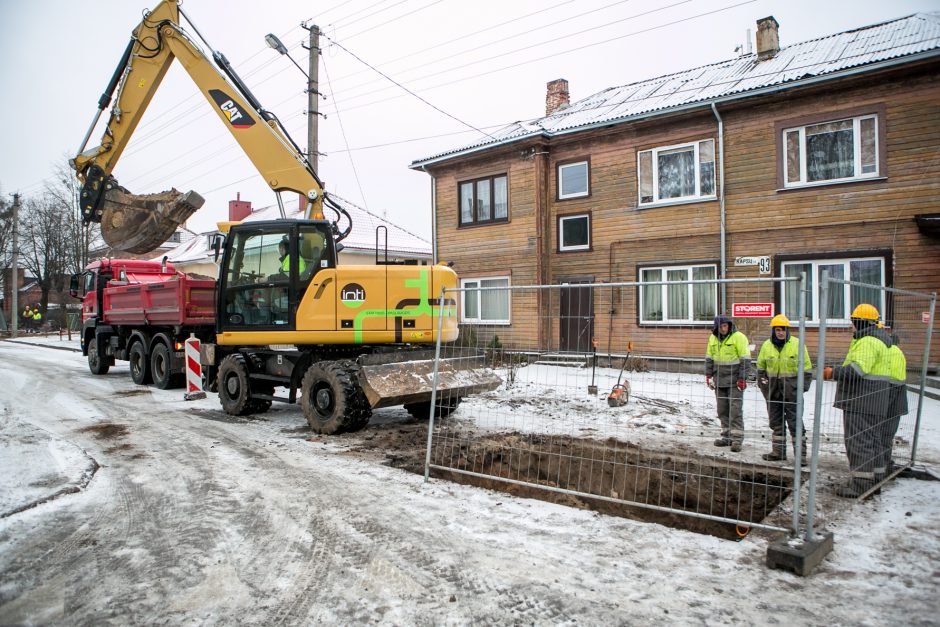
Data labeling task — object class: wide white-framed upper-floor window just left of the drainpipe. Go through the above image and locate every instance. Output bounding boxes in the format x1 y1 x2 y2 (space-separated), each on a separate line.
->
637 139 715 206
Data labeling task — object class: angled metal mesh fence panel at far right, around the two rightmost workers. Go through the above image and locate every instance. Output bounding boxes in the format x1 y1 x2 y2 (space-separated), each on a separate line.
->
817 277 936 497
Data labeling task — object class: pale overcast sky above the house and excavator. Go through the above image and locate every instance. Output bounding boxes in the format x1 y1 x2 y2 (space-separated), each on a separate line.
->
0 0 940 238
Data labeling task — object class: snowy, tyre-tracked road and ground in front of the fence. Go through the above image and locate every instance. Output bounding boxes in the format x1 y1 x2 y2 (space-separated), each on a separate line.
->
0 337 940 625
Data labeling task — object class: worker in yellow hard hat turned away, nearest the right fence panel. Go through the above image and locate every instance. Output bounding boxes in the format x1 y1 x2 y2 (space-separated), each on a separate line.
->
823 303 892 498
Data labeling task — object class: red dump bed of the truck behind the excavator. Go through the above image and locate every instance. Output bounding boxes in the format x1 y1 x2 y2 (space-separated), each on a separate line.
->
102 275 216 326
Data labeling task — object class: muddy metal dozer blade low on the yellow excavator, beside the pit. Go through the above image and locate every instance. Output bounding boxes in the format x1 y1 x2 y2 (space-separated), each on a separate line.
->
359 349 503 409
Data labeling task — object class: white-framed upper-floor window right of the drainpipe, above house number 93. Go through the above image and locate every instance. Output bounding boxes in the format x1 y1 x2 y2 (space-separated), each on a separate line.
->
783 115 878 187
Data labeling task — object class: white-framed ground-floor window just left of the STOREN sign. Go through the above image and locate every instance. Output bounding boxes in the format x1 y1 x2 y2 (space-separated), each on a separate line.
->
640 264 718 324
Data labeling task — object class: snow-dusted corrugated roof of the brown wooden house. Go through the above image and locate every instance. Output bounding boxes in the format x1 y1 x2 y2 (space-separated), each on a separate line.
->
411 13 940 168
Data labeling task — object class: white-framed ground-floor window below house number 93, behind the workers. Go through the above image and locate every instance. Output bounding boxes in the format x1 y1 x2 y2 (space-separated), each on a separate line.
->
781 257 885 324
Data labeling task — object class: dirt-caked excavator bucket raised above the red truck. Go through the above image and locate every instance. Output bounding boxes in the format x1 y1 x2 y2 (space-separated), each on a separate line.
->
101 187 205 254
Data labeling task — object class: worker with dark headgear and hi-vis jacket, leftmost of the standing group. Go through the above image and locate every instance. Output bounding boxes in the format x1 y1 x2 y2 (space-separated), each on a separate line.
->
705 316 751 453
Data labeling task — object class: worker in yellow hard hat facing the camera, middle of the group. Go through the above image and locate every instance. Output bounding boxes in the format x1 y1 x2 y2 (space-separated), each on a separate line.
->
757 314 813 465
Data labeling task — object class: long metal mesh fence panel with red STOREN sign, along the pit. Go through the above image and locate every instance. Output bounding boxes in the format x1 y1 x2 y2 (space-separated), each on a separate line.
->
428 280 812 532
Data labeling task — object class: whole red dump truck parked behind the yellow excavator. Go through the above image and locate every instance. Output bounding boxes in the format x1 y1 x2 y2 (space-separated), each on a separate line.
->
69 259 216 390
